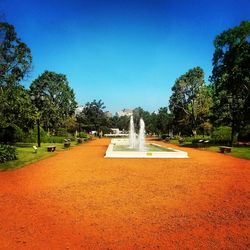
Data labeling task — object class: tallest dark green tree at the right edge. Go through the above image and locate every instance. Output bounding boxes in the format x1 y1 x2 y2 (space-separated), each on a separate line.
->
211 21 250 145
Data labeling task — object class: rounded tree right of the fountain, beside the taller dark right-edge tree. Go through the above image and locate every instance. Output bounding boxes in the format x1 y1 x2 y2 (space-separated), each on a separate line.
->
170 67 212 135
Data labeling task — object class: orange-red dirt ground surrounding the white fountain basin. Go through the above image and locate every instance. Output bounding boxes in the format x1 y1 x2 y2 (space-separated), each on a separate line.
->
0 139 250 250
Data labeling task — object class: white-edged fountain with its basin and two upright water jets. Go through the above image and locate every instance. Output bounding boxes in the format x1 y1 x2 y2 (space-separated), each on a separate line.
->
105 116 188 158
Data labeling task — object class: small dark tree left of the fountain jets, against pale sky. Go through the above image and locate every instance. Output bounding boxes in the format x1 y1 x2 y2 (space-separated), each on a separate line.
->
77 100 107 131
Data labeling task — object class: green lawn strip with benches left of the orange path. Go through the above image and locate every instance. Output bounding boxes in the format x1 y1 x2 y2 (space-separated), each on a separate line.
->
0 141 77 171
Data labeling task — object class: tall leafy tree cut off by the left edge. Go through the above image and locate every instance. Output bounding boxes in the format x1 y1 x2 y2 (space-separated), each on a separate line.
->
0 22 35 142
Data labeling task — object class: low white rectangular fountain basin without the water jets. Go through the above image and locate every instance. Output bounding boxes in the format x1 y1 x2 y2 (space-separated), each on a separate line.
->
105 139 188 158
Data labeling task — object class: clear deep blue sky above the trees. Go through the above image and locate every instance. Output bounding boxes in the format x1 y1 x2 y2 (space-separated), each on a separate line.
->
0 0 250 113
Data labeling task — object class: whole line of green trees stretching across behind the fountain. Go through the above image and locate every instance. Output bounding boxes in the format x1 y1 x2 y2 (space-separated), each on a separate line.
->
0 21 250 146
